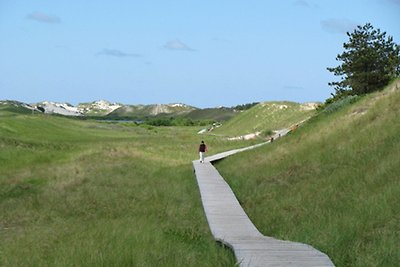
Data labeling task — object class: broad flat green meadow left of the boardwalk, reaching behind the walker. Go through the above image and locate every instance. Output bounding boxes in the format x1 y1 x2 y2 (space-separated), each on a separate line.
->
0 114 260 266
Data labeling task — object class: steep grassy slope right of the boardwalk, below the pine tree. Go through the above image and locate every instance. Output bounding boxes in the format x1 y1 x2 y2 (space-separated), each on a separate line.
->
217 80 400 266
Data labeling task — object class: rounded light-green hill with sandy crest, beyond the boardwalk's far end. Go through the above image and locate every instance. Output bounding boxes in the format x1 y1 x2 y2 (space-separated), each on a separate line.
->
214 101 315 136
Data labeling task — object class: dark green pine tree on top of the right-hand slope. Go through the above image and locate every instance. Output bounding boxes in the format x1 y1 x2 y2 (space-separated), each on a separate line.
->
327 23 400 97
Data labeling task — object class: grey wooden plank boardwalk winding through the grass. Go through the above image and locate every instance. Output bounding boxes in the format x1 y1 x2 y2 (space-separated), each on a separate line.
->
193 130 334 267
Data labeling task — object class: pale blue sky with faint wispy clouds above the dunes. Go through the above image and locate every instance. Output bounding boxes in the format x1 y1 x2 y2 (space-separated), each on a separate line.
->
0 0 400 107
